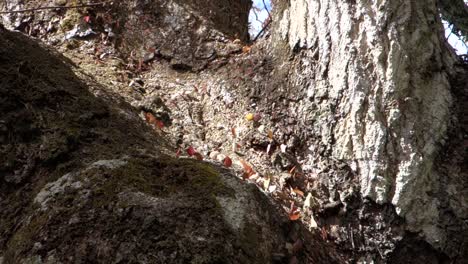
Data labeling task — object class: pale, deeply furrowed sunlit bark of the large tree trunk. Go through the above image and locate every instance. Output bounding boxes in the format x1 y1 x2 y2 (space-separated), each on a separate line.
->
271 0 467 255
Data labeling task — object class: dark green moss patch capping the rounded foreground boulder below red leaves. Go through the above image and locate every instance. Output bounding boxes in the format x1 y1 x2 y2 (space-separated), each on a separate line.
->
81 156 234 207
